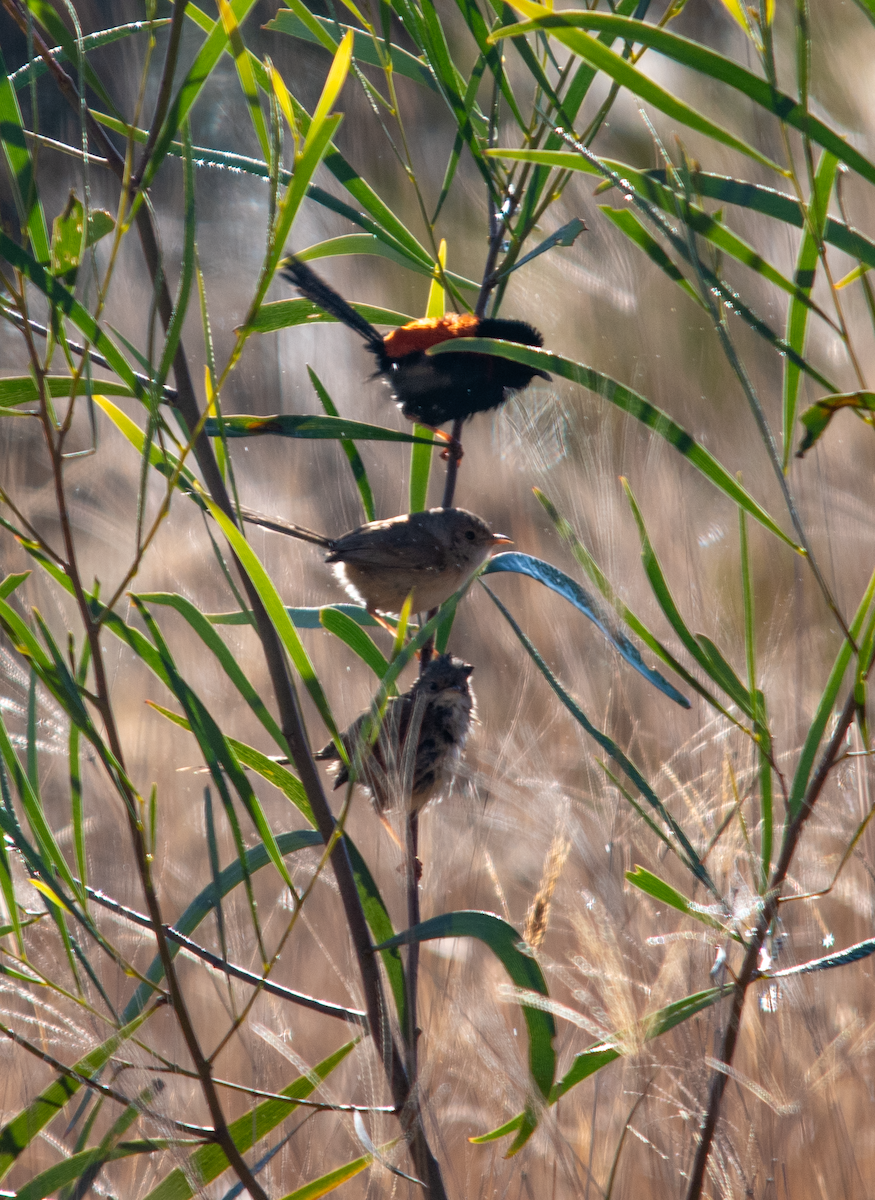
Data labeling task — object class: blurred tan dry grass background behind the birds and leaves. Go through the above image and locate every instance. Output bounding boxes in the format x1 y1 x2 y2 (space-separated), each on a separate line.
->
0 4 875 1200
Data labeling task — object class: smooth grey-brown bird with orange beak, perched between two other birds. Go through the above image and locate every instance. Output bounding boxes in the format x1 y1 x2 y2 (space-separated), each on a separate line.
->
241 509 511 613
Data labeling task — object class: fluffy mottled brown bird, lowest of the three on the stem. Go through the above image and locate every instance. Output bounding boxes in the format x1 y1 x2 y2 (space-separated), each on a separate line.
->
314 654 474 814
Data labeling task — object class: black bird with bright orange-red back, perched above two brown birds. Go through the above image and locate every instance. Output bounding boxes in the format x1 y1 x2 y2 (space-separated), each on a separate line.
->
282 256 550 428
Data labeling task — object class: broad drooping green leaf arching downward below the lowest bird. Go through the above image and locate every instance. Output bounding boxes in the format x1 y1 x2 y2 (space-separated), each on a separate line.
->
377 912 556 1097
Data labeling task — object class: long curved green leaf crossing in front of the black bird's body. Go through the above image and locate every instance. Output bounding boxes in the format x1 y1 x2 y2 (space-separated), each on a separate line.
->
428 337 802 553
